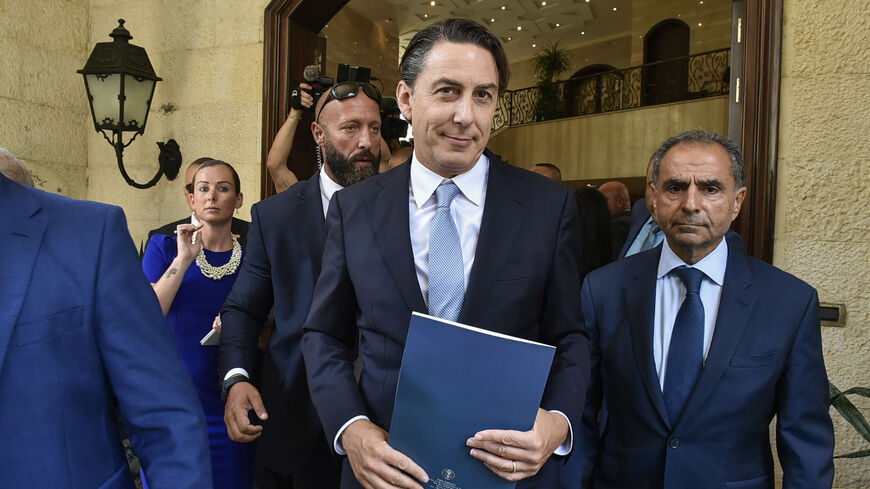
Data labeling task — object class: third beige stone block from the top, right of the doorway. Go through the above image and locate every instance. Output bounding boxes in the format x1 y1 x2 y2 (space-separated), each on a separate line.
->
778 158 870 244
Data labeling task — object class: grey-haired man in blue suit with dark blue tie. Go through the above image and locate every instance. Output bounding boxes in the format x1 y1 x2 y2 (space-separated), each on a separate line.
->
569 131 834 489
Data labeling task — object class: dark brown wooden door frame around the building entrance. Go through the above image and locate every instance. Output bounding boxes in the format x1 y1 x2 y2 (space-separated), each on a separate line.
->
261 0 783 262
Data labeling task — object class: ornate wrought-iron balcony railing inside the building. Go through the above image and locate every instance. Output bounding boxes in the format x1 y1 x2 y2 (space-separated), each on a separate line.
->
492 49 731 131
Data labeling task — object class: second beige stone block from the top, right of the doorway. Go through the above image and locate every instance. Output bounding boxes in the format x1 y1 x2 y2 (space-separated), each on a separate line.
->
780 75 870 161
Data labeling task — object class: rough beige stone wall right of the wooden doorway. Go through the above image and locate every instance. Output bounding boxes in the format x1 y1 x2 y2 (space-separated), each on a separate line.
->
774 0 870 489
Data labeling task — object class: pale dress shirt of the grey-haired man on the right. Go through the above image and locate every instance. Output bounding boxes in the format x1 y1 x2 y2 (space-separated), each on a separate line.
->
653 238 728 388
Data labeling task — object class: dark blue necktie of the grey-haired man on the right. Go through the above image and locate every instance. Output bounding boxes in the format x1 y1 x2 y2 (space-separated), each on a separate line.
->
662 266 704 423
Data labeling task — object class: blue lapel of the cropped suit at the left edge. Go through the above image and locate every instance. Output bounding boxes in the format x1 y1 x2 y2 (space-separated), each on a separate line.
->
0 176 45 370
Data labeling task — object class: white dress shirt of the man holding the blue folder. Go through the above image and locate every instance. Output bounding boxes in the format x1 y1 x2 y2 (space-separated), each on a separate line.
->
333 151 574 455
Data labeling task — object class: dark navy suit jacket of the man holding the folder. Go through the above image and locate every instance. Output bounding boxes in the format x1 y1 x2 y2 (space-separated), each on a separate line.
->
302 152 589 488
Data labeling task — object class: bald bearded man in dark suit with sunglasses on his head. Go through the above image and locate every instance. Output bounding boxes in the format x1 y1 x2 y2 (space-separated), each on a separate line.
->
220 78 381 489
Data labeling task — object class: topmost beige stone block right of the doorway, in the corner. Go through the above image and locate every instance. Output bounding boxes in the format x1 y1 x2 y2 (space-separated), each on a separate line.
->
783 0 870 74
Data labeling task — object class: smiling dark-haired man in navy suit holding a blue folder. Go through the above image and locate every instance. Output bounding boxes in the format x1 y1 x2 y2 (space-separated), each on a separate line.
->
302 19 589 488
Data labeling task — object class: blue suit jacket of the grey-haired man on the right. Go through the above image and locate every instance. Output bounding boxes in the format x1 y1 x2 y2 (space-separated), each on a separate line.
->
566 246 834 489
